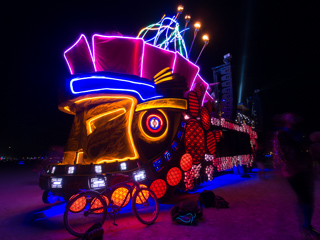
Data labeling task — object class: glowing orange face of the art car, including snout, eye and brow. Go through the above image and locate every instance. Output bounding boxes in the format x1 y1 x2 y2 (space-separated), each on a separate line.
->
59 94 187 164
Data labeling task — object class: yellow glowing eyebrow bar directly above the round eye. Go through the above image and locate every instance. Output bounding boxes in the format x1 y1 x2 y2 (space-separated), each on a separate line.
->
136 98 188 112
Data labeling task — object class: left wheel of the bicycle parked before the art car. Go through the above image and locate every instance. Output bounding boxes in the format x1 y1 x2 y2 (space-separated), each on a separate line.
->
63 191 107 237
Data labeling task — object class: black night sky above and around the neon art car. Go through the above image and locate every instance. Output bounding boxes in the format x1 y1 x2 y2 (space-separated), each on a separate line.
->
0 0 319 156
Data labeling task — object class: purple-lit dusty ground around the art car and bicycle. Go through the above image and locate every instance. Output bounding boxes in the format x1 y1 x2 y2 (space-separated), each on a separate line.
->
0 162 320 240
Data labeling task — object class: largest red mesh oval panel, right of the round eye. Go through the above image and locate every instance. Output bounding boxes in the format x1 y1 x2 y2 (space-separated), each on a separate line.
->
184 119 205 164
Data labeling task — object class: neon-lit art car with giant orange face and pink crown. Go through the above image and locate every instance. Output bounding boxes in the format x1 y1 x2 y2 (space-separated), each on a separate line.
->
40 14 257 202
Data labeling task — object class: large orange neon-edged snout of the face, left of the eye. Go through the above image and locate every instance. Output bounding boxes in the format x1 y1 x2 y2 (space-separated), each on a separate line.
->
60 94 139 164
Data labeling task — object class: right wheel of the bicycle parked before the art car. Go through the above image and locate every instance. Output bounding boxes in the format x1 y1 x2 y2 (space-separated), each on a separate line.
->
132 188 159 225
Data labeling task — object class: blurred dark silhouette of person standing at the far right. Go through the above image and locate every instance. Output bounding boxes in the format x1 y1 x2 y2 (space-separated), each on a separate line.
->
273 113 320 239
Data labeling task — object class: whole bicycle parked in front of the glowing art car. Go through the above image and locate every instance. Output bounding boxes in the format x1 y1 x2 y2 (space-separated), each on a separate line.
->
63 167 159 237
